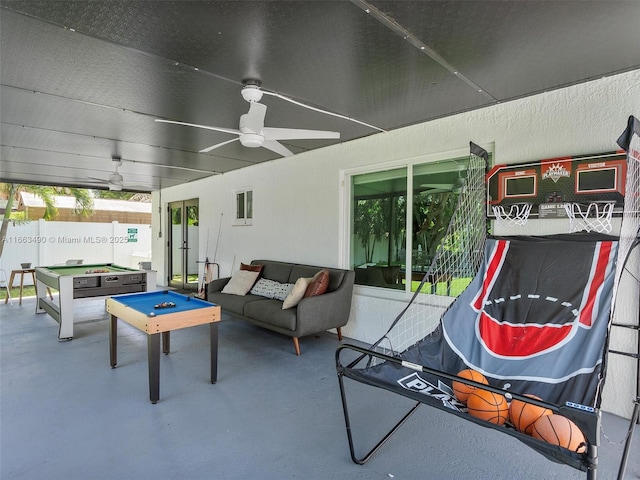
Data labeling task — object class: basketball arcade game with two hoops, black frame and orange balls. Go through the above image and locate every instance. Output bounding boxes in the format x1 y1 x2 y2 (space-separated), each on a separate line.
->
336 119 640 479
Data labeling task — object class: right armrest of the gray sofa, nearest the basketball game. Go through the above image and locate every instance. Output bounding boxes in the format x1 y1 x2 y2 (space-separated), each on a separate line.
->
296 271 355 336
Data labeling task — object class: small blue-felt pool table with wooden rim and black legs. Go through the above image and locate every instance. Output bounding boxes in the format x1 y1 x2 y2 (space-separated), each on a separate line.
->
106 290 221 403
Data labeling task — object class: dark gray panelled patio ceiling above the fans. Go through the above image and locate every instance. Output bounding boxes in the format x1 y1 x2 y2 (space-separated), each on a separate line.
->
0 0 640 190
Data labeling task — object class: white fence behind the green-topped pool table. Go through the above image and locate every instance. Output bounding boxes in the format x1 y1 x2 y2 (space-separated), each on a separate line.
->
0 220 151 284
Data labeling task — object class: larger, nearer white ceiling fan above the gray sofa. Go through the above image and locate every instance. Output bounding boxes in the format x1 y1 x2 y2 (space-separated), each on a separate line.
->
156 82 340 157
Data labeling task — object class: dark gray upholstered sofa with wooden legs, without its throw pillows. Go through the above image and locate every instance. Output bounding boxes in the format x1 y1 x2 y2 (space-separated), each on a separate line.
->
207 260 355 355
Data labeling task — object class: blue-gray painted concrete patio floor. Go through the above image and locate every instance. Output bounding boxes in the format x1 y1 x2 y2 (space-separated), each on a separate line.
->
0 298 640 480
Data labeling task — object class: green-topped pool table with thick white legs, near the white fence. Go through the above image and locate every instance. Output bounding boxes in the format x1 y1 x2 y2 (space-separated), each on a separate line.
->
36 263 156 340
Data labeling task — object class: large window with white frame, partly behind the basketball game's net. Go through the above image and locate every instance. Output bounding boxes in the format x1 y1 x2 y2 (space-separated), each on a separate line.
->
347 155 468 294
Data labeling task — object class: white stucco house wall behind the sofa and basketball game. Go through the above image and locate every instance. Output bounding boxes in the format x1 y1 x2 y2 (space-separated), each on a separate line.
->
153 70 640 417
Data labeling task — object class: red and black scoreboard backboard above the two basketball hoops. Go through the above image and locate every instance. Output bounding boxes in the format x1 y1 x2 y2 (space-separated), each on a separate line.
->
486 151 627 218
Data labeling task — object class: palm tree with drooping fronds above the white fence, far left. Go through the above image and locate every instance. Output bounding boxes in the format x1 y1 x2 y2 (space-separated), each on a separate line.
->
0 183 93 257
